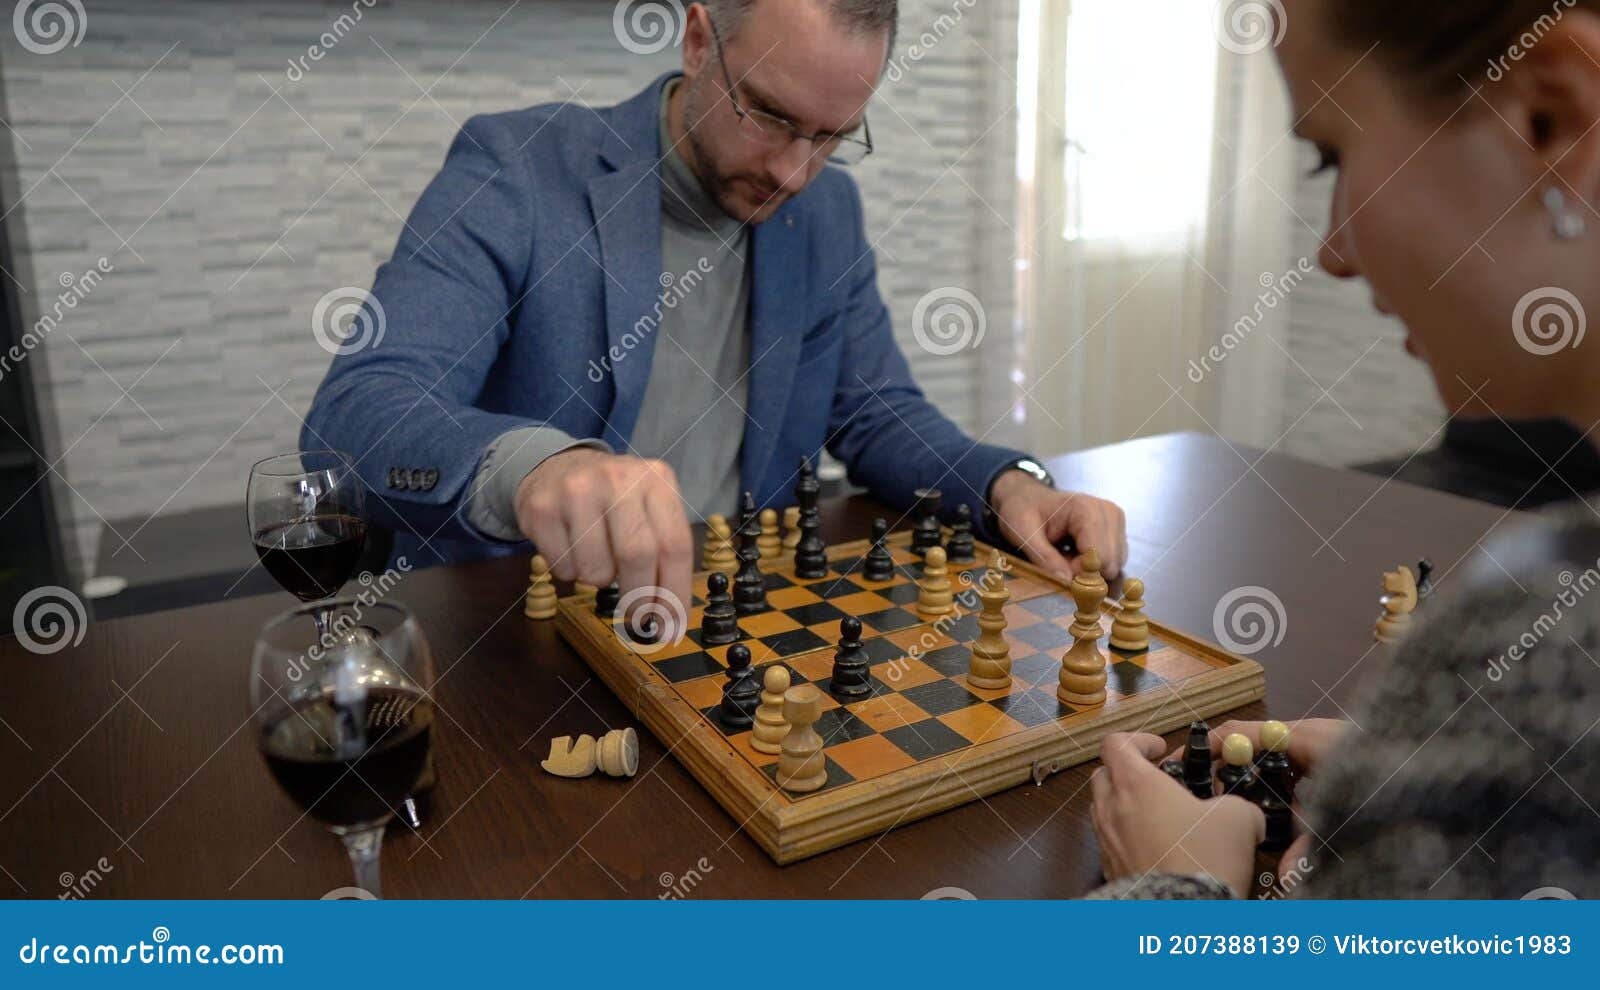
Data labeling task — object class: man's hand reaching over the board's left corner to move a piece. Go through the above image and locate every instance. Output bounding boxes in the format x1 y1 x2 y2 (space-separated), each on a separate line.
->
517 448 694 633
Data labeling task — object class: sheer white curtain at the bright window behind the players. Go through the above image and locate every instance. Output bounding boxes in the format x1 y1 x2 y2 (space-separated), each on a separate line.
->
1013 0 1293 451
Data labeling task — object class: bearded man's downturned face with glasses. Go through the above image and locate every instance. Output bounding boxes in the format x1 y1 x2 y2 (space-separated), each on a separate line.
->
683 0 888 224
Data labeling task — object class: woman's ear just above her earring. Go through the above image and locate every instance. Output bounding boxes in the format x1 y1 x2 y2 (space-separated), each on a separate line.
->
1483 10 1600 205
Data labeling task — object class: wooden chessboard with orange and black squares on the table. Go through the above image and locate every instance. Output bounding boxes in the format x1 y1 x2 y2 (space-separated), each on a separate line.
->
557 533 1266 864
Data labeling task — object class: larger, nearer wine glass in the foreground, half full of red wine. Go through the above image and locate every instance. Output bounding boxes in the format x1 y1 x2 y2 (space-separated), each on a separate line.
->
250 598 434 897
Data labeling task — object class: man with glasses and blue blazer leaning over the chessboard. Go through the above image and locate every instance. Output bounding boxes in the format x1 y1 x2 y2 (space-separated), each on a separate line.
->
302 0 1126 617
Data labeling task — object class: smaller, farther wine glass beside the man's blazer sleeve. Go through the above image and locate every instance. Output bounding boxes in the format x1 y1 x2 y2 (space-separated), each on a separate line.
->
245 451 366 632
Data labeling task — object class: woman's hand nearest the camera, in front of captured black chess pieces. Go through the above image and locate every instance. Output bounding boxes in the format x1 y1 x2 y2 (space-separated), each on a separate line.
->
1090 733 1267 897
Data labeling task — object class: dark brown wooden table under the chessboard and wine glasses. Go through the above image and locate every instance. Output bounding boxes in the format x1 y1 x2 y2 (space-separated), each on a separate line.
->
0 435 1506 897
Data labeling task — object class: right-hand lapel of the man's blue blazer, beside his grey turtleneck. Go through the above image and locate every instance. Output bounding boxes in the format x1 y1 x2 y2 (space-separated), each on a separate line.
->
739 206 806 489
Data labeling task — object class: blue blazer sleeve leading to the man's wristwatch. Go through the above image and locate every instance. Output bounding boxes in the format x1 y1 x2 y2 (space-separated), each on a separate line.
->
827 174 1026 541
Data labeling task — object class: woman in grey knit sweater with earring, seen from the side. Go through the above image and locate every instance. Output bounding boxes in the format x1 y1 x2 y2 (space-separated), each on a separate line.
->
1093 0 1600 899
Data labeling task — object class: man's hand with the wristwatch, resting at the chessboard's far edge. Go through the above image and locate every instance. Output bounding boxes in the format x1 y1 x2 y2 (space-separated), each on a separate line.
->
989 470 1128 581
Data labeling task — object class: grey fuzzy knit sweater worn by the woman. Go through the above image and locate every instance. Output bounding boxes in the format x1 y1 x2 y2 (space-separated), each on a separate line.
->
1090 504 1600 899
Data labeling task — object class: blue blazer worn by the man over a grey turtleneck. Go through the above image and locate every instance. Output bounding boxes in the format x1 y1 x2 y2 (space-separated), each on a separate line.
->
301 75 1022 566
